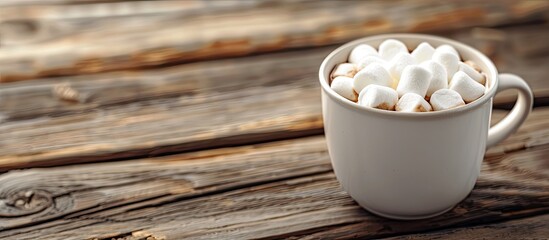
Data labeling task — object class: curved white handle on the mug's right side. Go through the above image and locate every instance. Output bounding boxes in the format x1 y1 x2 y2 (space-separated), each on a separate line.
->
486 73 534 148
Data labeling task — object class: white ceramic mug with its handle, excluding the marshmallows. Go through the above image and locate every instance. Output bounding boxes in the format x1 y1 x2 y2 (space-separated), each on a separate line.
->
319 34 533 220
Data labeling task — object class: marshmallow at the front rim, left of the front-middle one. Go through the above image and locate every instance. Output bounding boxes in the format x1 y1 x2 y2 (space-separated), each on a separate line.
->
358 85 398 110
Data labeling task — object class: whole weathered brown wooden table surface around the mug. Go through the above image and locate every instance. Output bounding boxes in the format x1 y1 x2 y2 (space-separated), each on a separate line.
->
0 0 549 240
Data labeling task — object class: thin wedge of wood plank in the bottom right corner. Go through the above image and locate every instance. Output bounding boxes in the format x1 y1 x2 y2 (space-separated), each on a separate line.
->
388 214 549 240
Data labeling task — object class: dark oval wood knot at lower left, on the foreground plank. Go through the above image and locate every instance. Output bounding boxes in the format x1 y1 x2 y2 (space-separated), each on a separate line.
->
0 190 53 217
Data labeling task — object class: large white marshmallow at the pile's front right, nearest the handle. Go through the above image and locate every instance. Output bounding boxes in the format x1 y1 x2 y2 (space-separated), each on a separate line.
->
450 71 485 103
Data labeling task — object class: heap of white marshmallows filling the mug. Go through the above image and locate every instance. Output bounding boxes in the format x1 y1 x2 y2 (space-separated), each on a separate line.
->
330 39 486 112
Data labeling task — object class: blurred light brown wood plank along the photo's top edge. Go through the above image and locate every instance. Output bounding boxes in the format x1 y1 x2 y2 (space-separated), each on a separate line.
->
0 0 549 82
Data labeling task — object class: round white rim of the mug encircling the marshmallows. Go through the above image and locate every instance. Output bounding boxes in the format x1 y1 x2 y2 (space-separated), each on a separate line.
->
319 33 498 118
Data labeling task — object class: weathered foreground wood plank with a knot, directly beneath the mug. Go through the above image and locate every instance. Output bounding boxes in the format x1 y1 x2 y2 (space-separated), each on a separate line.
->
0 137 549 239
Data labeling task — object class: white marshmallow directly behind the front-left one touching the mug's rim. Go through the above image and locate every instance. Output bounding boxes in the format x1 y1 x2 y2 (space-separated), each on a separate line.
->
353 63 393 92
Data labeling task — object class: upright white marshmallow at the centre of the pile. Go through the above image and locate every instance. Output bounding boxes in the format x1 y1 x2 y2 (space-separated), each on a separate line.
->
397 65 432 97
